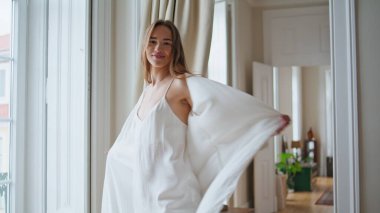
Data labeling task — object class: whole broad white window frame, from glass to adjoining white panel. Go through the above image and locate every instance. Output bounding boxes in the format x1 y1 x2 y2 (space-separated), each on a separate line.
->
10 0 48 213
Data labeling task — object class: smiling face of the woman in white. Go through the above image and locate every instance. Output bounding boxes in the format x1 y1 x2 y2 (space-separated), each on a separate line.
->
145 25 172 69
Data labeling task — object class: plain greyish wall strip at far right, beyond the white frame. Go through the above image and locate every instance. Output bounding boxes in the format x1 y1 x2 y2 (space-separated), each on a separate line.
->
356 0 380 212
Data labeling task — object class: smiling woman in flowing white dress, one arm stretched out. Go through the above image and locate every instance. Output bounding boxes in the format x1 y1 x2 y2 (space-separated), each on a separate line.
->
102 20 289 213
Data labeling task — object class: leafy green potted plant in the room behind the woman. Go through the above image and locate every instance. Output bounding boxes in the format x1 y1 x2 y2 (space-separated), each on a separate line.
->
276 152 302 190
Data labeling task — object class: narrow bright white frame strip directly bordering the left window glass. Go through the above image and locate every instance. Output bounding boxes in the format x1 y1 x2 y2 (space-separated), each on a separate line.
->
10 1 27 213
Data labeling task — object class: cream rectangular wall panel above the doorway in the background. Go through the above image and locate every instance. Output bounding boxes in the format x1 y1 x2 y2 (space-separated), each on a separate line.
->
263 6 330 66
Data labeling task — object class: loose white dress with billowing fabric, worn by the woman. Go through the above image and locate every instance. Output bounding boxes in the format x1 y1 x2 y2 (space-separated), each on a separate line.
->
102 76 281 213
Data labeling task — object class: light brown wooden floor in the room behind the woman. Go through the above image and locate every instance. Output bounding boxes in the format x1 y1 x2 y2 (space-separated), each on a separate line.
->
223 177 334 213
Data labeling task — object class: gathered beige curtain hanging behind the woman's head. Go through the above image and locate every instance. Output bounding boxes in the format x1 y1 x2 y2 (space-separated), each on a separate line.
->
140 0 214 74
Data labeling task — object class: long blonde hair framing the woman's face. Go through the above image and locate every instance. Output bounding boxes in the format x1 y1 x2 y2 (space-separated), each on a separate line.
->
141 20 191 83
